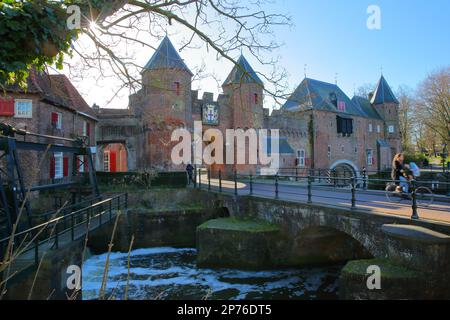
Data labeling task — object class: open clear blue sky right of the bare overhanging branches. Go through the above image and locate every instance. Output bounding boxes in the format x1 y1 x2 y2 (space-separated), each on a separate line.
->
264 0 450 95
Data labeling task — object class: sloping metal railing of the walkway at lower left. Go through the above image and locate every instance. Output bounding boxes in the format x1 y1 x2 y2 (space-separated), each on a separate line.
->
0 193 128 267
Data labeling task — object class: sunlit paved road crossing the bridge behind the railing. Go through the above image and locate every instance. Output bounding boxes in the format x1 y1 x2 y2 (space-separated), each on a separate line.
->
202 176 450 223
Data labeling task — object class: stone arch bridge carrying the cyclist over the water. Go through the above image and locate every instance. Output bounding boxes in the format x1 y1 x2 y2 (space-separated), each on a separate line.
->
206 193 450 299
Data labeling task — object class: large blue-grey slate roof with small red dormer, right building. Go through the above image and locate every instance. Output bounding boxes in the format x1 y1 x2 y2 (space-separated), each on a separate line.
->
283 78 367 117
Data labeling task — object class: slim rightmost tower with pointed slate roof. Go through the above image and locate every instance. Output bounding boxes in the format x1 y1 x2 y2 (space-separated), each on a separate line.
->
370 75 402 154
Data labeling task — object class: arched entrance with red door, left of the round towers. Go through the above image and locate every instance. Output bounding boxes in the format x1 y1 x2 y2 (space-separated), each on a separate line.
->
99 143 128 172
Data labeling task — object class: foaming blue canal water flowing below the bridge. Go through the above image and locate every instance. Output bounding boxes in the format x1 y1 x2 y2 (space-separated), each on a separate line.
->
83 248 343 300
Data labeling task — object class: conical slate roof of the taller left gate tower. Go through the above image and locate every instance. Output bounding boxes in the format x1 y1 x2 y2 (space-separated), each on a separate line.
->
144 36 193 75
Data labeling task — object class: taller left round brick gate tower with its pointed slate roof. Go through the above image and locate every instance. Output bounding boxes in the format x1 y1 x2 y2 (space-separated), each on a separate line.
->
137 36 193 170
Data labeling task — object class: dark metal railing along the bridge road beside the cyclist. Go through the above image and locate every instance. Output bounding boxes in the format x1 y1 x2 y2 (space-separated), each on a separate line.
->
195 169 450 219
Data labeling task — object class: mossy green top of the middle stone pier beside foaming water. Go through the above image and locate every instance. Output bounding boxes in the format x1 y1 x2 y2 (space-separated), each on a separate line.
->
198 218 279 232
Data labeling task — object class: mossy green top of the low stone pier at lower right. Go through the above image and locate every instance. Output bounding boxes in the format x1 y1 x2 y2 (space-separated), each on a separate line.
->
342 259 421 279
